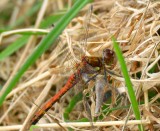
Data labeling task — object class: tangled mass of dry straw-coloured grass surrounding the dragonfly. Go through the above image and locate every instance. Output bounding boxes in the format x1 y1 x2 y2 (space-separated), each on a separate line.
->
0 0 160 130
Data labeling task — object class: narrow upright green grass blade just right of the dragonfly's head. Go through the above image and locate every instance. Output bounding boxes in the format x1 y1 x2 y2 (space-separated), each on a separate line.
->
112 37 143 131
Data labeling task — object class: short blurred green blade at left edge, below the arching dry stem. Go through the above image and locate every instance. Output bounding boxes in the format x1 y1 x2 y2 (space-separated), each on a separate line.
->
0 36 29 61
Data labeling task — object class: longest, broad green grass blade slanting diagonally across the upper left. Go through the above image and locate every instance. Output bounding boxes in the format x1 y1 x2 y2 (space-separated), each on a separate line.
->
0 0 91 106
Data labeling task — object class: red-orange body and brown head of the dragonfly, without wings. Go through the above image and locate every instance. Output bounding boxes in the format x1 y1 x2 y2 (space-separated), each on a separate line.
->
30 49 115 125
